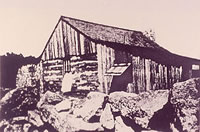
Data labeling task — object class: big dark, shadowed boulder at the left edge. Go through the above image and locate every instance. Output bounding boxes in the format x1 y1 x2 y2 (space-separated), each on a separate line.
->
0 87 40 119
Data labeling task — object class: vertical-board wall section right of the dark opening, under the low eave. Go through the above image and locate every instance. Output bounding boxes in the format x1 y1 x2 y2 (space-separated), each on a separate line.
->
132 56 181 93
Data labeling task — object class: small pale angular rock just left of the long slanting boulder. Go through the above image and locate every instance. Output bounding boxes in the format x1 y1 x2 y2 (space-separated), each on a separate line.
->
28 110 44 127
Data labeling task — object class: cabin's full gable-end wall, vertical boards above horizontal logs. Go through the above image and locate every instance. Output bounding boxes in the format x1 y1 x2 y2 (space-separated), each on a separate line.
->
41 20 99 91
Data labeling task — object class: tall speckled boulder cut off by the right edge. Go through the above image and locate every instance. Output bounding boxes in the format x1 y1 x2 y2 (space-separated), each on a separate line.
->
170 78 200 132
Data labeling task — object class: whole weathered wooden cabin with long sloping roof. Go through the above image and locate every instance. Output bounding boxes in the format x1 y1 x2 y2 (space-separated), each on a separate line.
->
40 16 200 93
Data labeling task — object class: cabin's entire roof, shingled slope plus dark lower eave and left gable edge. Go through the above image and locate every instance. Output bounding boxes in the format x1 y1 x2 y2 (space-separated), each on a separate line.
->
39 16 200 65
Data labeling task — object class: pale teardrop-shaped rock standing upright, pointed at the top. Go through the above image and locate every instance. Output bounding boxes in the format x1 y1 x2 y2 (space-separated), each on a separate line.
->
100 103 114 130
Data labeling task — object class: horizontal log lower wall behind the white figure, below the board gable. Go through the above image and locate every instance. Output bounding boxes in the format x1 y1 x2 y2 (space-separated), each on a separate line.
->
42 55 99 92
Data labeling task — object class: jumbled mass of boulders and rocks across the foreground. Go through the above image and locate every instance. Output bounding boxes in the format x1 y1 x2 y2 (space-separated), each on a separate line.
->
0 78 200 132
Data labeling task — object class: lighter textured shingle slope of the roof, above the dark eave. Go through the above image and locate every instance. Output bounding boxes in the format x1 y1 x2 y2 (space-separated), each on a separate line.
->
61 16 168 52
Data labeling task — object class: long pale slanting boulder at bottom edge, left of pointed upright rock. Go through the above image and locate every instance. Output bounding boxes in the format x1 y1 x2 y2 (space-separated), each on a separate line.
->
40 105 104 132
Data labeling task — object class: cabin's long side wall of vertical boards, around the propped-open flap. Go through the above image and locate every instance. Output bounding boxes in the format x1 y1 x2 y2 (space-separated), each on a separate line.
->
97 44 182 93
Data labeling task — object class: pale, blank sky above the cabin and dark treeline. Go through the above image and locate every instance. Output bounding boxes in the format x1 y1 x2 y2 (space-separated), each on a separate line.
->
0 0 200 59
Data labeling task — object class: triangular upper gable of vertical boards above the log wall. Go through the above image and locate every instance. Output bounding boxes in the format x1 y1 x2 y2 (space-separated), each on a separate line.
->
42 21 96 60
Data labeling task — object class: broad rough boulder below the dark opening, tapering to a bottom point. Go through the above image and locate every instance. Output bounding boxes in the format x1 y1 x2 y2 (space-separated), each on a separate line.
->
109 90 169 128
